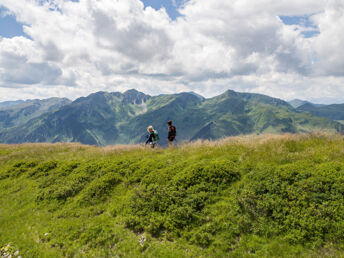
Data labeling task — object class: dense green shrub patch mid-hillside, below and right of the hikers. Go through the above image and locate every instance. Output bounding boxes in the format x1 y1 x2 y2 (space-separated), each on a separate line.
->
127 161 240 236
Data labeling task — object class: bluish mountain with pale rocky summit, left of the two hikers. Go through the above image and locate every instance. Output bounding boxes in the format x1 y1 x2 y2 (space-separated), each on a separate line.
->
0 91 149 145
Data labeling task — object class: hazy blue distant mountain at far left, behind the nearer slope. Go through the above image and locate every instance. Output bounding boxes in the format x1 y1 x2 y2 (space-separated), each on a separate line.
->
0 98 71 130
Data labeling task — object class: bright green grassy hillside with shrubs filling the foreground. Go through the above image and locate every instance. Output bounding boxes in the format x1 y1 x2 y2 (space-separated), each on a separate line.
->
0 134 344 257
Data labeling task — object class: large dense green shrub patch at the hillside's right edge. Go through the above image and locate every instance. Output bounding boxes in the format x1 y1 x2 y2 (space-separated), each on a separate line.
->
238 161 344 244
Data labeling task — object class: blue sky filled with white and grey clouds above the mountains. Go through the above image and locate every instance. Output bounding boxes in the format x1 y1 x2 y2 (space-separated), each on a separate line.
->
0 0 344 104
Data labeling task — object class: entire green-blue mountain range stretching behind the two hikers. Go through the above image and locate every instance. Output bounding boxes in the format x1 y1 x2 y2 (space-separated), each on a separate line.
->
0 90 344 145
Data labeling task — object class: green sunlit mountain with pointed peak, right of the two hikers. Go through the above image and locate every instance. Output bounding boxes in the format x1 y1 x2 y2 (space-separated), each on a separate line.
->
189 91 343 139
